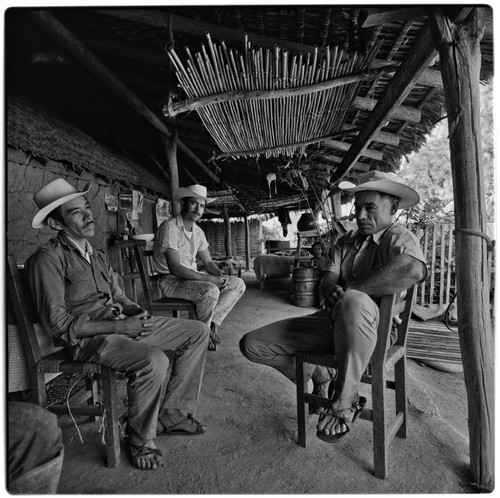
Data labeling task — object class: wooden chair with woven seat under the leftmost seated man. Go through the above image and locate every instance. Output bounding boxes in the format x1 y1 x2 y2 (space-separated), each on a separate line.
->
7 256 120 468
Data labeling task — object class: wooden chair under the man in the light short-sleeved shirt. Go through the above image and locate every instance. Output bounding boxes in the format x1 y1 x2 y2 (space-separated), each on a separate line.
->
114 240 196 320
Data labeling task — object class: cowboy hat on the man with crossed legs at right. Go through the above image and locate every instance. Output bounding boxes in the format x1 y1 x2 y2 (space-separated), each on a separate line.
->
339 170 420 209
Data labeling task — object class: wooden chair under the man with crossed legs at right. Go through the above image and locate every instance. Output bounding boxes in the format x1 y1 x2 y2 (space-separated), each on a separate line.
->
296 287 414 479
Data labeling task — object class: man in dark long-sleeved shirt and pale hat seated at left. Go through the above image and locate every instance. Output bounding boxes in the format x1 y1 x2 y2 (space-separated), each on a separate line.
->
26 178 209 470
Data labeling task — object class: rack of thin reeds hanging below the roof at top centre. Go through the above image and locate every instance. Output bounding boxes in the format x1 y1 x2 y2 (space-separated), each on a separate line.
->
164 34 374 157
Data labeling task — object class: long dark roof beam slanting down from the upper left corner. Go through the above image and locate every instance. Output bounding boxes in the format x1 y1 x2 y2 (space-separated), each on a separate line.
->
26 10 220 182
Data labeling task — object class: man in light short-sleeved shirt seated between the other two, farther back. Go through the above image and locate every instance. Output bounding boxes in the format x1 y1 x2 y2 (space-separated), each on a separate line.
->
153 185 245 351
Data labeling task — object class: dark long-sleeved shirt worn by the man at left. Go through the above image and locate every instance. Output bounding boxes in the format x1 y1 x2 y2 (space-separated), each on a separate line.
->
25 232 135 346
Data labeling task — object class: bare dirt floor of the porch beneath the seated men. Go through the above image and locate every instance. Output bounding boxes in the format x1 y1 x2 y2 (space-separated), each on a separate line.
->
58 272 475 495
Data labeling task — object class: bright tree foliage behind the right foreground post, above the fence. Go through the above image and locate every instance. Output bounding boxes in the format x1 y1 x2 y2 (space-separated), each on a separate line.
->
398 82 495 223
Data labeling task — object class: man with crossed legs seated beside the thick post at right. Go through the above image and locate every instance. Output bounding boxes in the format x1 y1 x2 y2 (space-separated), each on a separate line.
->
240 171 427 443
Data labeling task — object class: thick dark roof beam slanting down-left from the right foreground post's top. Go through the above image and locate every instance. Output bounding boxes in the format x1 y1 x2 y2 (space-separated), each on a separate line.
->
337 20 437 178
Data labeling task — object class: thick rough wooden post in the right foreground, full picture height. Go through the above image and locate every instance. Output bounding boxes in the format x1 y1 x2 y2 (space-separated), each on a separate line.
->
432 8 495 492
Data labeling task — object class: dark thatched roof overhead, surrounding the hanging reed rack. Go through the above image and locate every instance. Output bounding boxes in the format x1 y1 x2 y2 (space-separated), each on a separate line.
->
6 5 493 215
